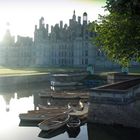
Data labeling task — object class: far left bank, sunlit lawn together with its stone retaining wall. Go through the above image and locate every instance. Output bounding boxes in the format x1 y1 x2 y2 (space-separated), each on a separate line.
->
0 68 83 86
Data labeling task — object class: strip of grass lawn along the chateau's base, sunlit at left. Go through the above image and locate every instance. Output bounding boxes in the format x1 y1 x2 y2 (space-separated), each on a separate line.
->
0 66 140 77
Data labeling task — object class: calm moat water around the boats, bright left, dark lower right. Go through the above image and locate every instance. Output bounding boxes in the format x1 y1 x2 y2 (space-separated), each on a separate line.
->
0 83 140 140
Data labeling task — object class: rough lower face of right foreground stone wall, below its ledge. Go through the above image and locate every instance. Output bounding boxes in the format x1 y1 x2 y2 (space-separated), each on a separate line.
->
88 101 140 128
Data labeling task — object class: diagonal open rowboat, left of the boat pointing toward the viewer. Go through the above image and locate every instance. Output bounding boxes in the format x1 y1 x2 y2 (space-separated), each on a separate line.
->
38 113 70 131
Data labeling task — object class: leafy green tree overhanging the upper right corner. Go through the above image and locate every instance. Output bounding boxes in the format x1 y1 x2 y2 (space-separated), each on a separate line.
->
92 0 140 66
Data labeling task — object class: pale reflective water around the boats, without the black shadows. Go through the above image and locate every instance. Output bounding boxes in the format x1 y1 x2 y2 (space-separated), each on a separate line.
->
0 83 87 140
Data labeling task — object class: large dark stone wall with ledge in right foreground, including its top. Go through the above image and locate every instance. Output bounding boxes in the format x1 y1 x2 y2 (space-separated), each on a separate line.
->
88 79 140 128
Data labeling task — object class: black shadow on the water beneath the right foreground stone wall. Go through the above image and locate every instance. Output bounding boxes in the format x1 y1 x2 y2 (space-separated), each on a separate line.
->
87 123 140 140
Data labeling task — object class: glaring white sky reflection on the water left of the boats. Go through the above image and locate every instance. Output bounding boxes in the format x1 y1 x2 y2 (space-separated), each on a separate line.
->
0 93 34 132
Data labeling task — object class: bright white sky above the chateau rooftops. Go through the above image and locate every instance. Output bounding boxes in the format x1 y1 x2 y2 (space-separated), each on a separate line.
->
0 0 105 41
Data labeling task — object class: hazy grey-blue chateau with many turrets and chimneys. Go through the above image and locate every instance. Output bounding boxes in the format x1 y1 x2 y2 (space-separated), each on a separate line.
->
0 11 115 68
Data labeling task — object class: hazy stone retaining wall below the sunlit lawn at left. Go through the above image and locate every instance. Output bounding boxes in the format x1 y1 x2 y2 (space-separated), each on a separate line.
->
0 74 50 86
